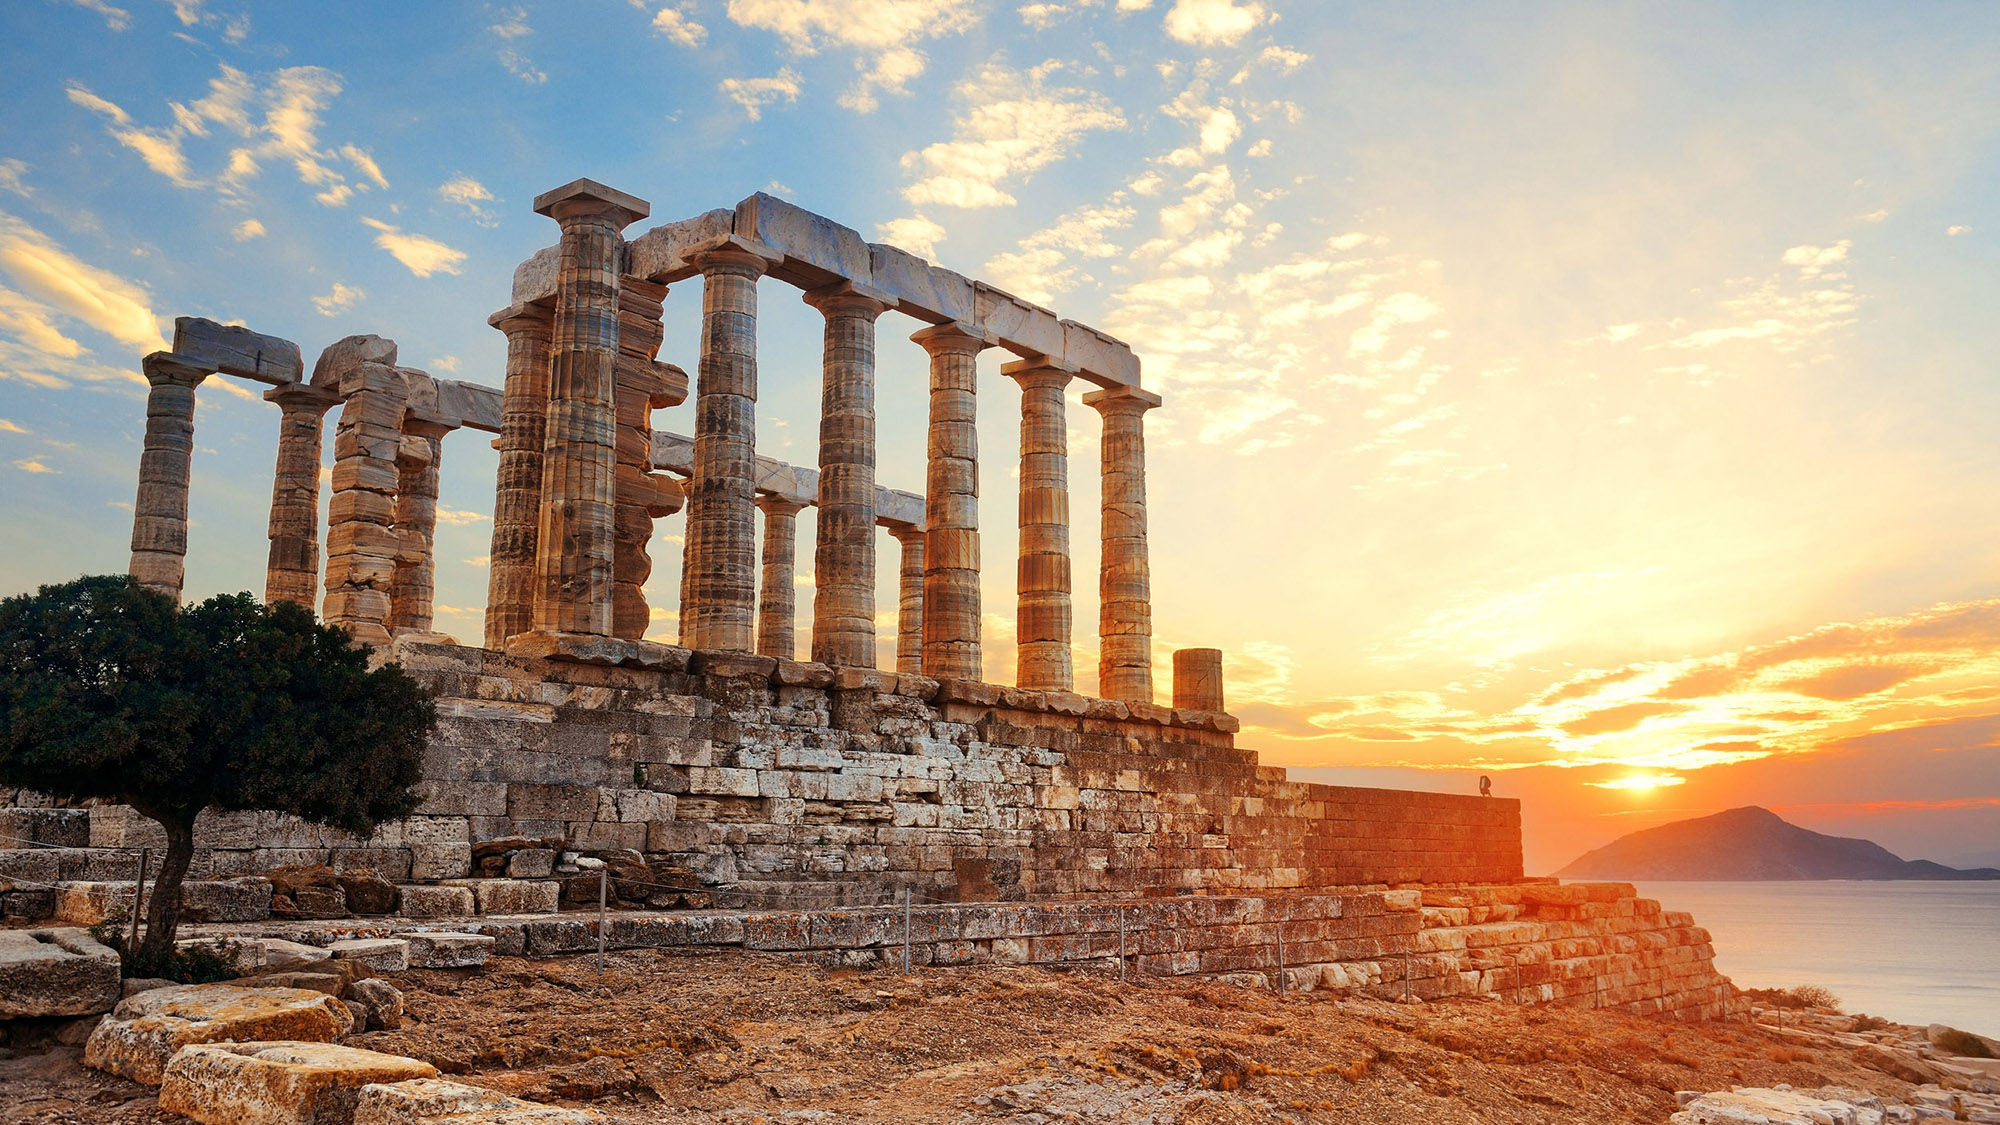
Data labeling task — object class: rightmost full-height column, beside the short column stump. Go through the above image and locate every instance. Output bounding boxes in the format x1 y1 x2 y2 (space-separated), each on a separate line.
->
1084 386 1160 703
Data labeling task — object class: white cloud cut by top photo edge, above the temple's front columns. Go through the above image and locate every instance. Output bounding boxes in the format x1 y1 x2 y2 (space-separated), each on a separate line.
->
728 0 980 112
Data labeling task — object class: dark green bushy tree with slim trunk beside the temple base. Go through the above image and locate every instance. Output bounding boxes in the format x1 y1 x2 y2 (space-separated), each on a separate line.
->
0 575 436 957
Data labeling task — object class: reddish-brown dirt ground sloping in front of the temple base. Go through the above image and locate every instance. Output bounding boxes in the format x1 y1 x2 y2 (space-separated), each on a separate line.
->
0 951 1910 1125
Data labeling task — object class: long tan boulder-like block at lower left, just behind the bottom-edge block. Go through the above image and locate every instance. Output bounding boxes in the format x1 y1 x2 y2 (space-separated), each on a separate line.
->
84 985 354 1085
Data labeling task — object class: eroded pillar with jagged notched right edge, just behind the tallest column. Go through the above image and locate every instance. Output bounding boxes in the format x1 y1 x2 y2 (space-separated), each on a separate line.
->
612 278 686 641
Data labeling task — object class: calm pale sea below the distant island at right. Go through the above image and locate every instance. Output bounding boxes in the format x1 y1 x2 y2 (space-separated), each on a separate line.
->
1636 881 2000 1037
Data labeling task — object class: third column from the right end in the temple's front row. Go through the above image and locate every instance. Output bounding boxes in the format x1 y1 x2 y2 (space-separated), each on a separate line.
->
916 324 986 681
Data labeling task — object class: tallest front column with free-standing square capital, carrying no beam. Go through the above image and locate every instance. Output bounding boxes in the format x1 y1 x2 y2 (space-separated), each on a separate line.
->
534 180 650 637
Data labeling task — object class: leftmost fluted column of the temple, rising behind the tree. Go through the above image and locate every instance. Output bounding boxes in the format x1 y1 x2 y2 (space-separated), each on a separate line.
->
132 352 214 599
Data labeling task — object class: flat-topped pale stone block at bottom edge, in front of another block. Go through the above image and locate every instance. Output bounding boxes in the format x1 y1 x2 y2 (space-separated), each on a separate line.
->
160 1040 438 1125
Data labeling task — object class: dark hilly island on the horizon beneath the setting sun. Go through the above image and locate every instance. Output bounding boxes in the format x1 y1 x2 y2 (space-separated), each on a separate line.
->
1556 805 2000 881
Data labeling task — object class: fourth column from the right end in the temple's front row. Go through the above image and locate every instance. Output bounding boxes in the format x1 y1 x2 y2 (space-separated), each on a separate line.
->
806 284 888 669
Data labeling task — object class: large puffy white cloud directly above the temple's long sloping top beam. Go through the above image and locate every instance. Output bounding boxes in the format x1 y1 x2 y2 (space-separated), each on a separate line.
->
902 60 1126 208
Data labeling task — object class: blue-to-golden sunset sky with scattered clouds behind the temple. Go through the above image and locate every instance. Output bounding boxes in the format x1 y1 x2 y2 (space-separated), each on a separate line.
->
0 0 2000 873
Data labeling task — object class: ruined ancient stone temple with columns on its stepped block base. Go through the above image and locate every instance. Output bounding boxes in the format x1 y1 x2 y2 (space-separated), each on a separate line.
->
19 180 1728 1013
